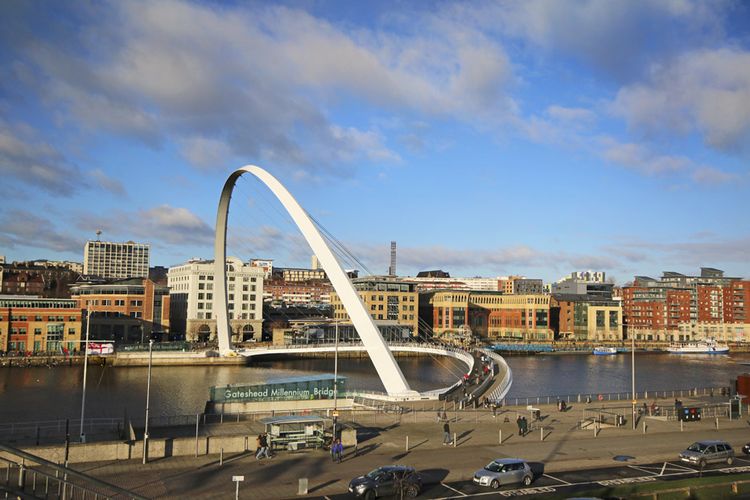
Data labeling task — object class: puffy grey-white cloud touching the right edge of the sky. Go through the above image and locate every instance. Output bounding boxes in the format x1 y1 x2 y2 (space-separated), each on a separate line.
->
612 48 750 152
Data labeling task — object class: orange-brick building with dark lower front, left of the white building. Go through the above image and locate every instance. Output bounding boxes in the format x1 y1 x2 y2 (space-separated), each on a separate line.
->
71 278 170 343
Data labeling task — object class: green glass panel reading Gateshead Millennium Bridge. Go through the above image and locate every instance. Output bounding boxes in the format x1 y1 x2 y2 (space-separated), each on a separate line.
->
210 375 346 403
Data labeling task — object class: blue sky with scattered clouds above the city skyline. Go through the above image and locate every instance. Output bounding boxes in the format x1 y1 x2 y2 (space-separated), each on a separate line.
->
0 0 750 283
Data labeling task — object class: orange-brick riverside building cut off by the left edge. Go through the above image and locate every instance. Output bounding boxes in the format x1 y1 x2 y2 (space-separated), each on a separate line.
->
0 295 81 353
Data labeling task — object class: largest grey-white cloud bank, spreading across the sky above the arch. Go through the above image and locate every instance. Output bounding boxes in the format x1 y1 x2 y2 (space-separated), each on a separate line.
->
5 0 516 174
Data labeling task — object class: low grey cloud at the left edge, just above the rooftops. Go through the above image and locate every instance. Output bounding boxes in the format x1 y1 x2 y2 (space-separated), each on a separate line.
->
0 209 83 253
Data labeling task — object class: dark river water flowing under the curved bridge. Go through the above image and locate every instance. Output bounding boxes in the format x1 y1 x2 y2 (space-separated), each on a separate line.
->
0 354 750 423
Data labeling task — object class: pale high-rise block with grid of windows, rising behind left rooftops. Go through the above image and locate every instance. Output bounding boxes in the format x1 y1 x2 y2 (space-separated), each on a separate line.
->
83 241 149 279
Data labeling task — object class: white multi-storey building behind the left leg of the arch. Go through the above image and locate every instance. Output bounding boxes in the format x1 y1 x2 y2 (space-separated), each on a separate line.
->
168 257 263 342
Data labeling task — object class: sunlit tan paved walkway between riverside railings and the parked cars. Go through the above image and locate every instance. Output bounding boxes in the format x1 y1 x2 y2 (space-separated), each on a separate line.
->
67 398 750 499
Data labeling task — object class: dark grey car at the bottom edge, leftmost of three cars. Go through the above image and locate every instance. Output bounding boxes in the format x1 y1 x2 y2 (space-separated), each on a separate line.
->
349 465 422 500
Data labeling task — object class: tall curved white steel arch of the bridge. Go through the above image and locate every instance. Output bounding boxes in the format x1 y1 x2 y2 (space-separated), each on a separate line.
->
214 165 417 395
